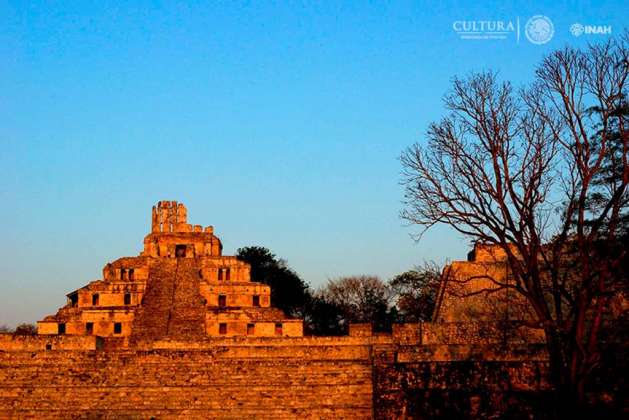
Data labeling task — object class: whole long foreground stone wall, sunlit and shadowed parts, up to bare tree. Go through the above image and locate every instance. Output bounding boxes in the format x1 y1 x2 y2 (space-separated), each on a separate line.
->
0 326 548 419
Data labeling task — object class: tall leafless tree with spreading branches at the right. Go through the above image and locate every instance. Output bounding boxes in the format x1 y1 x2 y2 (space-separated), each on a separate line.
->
401 33 629 414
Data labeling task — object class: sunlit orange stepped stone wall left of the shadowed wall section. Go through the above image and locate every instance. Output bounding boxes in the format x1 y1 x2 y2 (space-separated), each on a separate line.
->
0 348 372 419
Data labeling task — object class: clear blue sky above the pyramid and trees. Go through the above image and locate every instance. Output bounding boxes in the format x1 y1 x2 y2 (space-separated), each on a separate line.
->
0 1 629 325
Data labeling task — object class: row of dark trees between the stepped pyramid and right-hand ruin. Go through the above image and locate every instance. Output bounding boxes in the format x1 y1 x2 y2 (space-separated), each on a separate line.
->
237 246 440 335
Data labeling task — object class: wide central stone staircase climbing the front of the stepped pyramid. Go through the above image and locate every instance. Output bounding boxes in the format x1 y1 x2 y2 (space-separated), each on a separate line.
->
129 258 206 345
